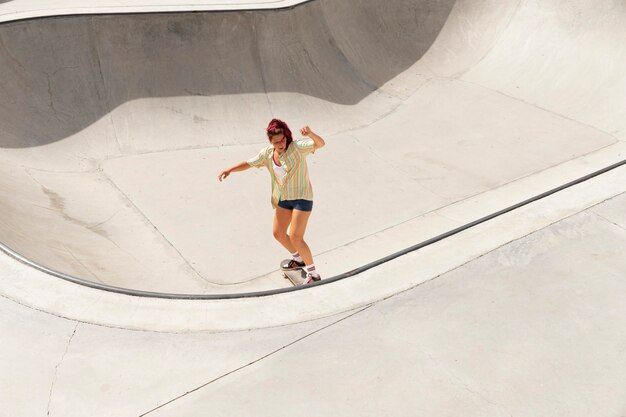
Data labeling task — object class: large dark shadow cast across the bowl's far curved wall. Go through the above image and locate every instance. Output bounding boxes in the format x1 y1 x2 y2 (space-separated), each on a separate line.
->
0 0 455 148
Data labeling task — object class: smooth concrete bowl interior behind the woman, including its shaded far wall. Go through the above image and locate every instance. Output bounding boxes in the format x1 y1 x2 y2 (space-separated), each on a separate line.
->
0 0 626 293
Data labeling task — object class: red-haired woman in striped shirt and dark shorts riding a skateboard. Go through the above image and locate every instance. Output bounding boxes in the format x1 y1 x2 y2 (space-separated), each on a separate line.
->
218 119 326 284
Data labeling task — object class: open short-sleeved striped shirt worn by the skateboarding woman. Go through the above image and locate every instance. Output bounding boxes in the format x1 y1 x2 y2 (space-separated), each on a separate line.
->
247 139 315 208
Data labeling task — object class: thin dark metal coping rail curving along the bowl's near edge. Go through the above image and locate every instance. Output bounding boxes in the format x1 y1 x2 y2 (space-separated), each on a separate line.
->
0 159 626 300
